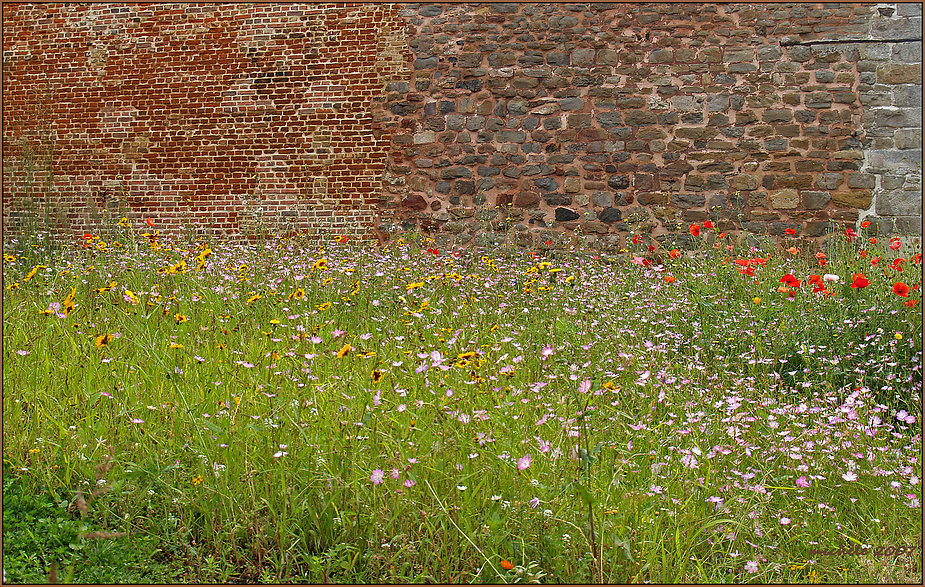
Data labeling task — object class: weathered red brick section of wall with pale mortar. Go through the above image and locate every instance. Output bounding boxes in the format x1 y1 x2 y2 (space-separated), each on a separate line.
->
3 4 407 241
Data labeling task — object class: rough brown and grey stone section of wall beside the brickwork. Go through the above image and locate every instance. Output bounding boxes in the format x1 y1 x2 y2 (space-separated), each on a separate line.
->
381 3 922 247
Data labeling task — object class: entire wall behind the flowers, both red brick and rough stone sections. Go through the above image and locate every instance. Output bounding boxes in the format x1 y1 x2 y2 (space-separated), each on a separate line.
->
3 3 922 248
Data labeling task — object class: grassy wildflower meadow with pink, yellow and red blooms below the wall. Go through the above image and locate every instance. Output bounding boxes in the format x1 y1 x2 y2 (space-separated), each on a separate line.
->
3 219 922 583
